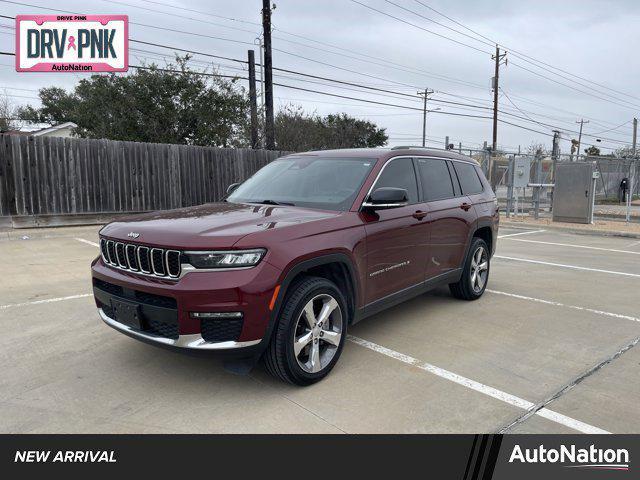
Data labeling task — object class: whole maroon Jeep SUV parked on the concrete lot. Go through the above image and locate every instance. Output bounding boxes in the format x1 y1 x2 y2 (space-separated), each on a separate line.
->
92 147 499 385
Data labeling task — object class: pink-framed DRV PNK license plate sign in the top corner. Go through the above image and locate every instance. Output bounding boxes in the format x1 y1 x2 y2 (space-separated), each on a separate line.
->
16 15 129 72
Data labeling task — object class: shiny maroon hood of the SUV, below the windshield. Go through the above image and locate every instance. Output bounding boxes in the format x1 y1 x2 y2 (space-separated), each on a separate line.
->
100 203 340 249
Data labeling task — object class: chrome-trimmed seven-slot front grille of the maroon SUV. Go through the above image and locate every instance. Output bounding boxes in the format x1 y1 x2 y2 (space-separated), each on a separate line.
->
100 238 182 278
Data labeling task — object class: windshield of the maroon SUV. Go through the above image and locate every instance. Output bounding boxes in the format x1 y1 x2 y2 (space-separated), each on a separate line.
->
227 157 376 211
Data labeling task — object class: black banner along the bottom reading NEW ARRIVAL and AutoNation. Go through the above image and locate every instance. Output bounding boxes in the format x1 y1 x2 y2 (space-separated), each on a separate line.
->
0 435 640 480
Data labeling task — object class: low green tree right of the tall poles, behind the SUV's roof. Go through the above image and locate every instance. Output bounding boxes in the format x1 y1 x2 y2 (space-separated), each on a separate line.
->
275 105 389 152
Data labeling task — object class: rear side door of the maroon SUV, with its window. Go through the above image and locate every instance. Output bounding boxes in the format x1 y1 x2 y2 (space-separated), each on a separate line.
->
416 158 475 279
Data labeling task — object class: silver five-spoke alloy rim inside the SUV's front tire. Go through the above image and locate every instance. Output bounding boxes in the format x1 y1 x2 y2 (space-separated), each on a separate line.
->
293 293 342 373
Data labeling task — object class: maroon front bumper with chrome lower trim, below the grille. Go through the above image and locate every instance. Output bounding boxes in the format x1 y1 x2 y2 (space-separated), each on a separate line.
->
91 257 280 354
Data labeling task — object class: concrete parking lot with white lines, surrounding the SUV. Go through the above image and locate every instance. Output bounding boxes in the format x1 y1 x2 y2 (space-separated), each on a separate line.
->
0 227 640 433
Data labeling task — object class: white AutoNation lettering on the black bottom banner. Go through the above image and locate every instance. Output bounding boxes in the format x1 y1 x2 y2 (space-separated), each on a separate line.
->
509 445 629 470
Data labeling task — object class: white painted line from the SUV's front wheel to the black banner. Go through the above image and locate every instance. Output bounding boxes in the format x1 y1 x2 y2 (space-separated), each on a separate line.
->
347 335 610 434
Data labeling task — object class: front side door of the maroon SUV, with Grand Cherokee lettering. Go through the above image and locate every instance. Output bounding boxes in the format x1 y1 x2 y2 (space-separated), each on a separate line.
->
362 157 429 304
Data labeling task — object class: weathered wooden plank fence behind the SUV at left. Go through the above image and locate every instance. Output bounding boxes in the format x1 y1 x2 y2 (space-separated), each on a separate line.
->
0 135 287 223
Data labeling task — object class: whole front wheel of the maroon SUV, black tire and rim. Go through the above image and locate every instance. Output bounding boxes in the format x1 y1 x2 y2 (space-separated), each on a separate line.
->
263 276 349 386
